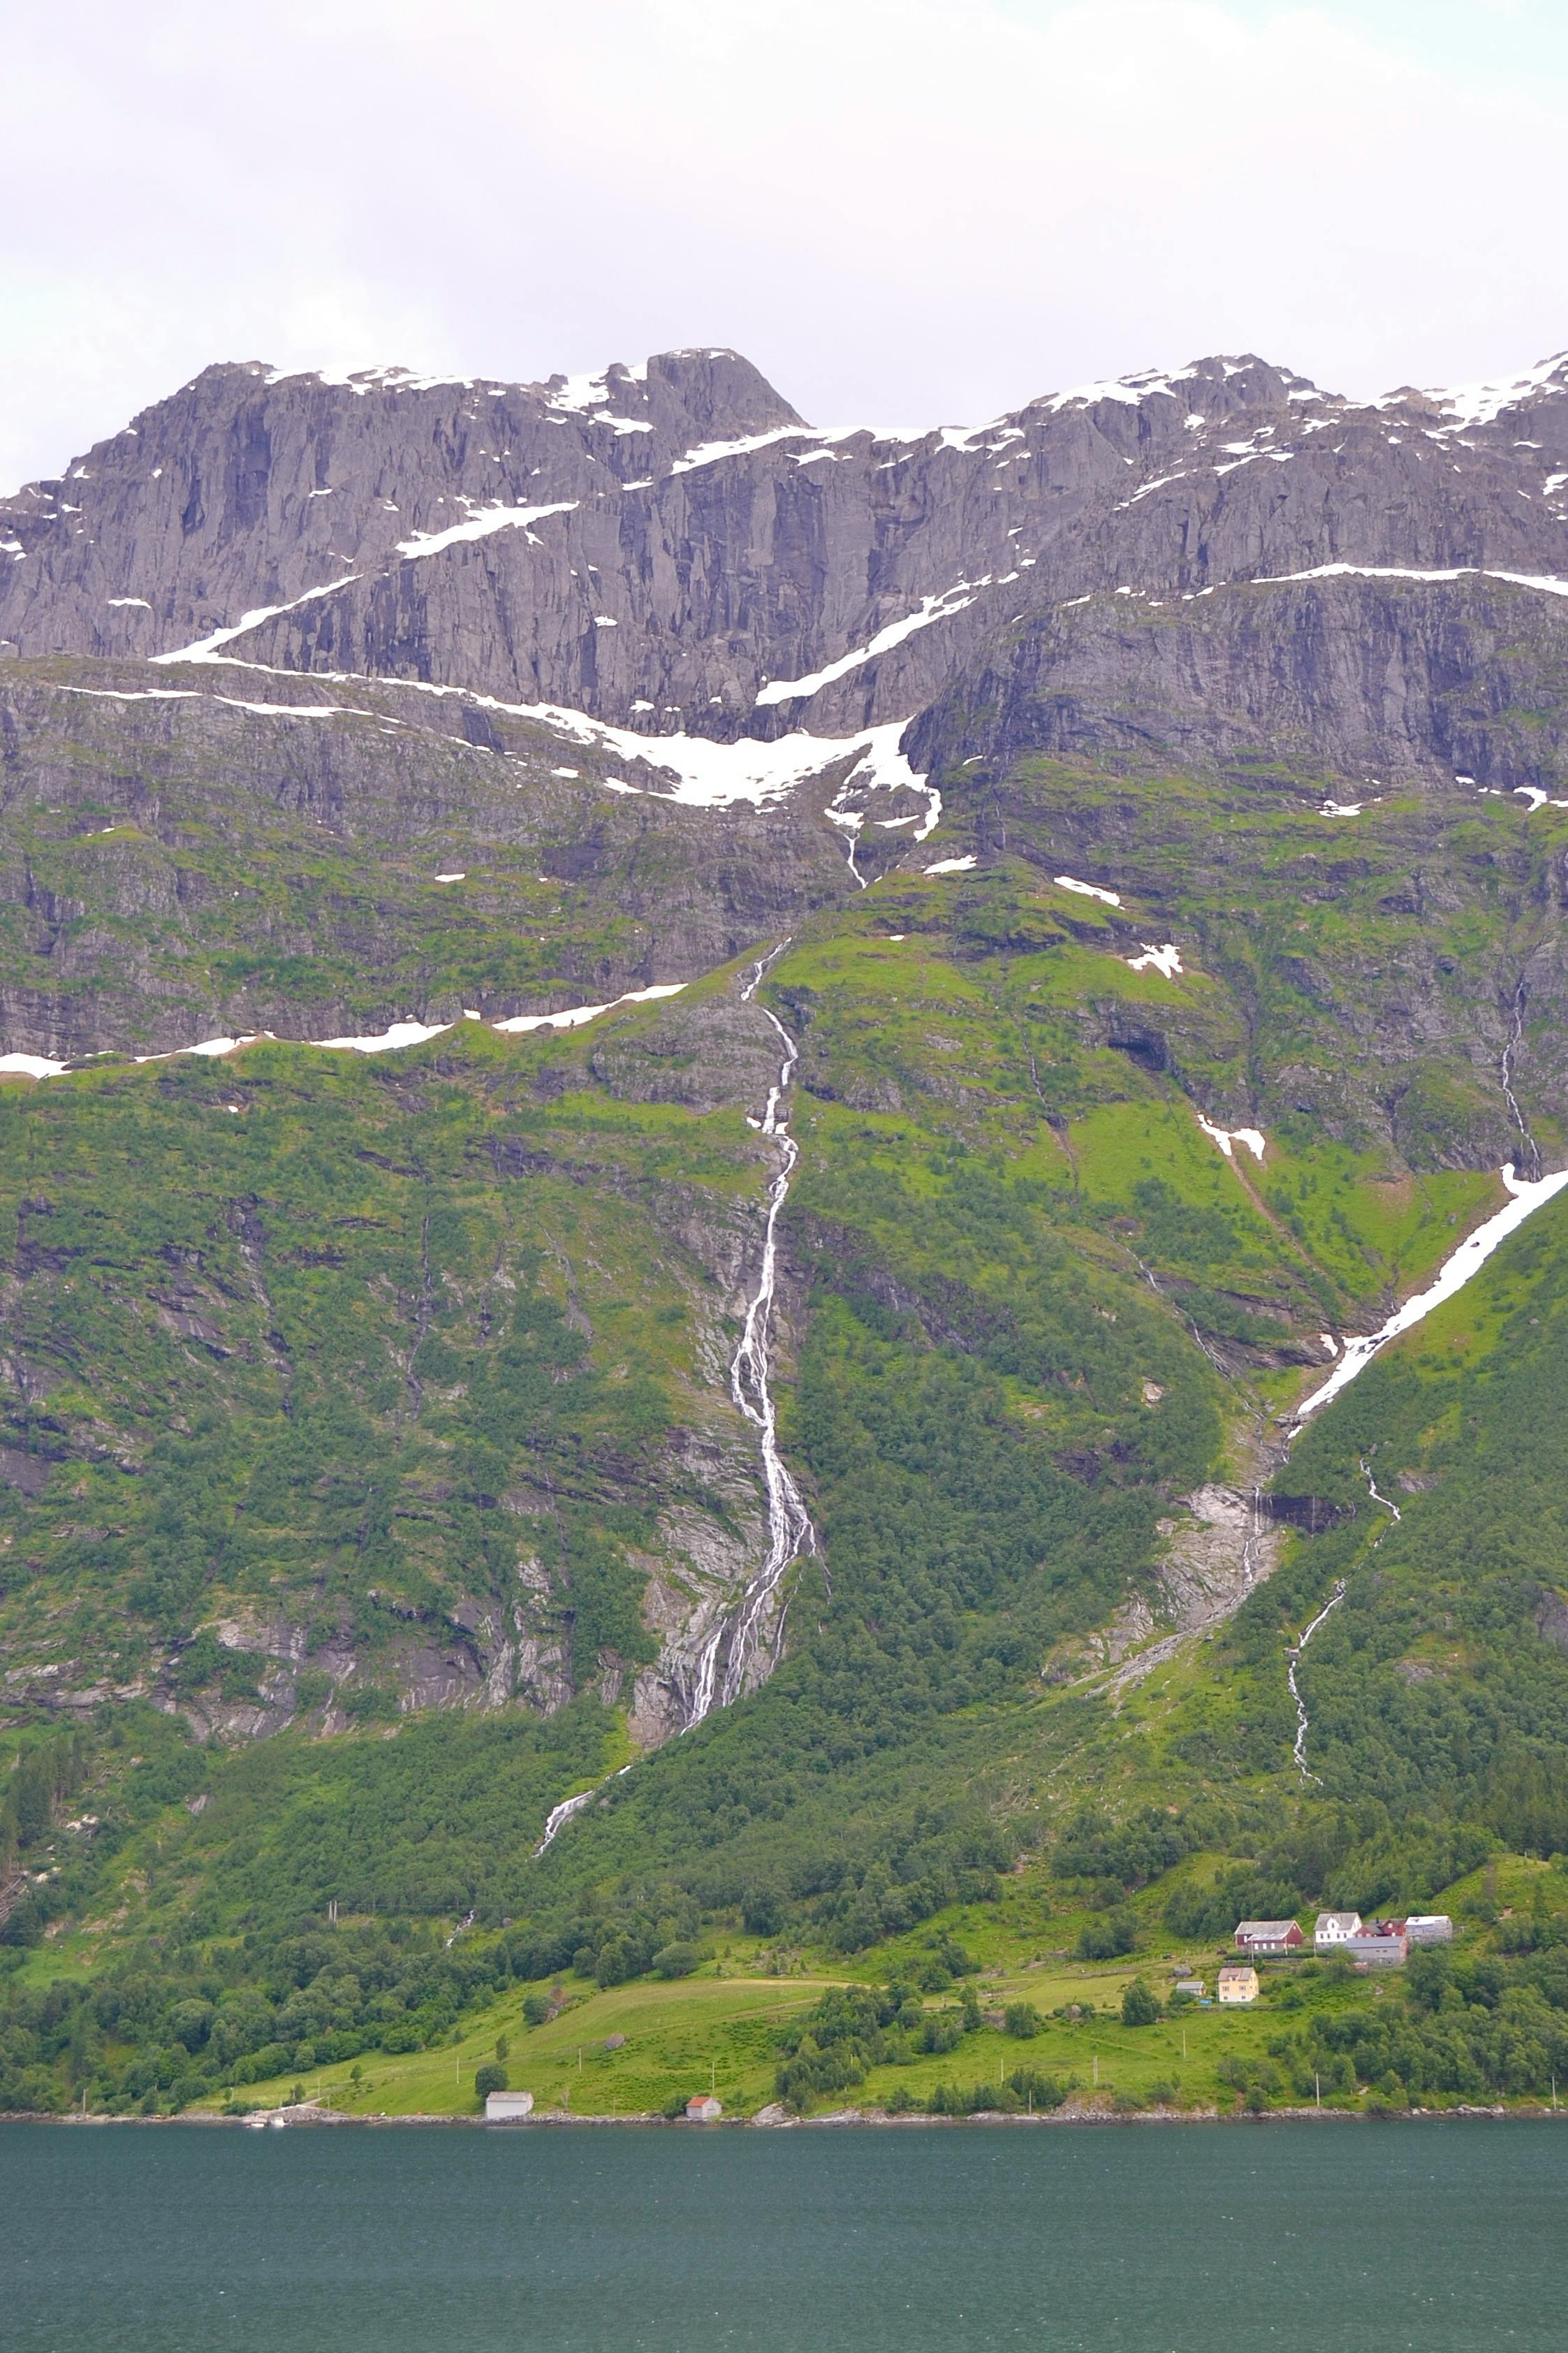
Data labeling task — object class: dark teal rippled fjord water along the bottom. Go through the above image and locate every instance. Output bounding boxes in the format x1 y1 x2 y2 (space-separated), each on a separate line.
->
0 2120 1568 2353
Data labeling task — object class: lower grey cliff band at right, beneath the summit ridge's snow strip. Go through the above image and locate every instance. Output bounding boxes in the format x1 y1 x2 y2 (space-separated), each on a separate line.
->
910 574 1568 798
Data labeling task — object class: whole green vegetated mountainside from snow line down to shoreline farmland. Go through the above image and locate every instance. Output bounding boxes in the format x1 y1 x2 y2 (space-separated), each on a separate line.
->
0 767 1568 2099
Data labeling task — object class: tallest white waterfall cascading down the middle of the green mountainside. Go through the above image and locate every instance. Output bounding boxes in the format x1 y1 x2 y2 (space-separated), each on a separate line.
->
684 941 816 1732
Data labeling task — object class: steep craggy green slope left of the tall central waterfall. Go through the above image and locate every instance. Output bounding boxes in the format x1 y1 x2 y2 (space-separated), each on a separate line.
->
0 983 804 1729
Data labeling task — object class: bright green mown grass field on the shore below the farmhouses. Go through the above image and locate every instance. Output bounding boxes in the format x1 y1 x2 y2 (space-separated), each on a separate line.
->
202 1856 1544 2118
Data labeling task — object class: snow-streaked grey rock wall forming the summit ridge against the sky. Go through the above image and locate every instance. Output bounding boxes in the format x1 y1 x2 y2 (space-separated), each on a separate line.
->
0 336 1568 736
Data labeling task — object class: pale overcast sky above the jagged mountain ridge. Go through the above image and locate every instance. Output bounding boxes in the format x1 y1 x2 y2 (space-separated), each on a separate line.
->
0 0 1568 487
